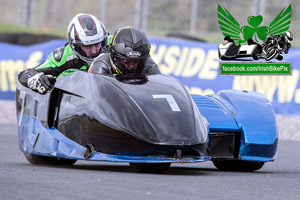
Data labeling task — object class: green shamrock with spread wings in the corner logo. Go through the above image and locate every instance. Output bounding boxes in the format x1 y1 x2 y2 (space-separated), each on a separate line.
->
218 4 292 44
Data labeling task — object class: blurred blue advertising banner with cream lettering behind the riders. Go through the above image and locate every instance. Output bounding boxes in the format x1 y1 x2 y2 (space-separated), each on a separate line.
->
0 38 300 115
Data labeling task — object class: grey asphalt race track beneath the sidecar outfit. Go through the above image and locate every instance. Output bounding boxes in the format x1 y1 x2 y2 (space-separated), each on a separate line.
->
0 124 300 200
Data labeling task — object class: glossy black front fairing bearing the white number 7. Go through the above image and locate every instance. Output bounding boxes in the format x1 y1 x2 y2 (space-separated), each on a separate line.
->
57 72 208 145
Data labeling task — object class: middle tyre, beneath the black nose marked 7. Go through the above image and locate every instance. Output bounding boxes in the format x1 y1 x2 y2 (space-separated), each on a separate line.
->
130 163 171 174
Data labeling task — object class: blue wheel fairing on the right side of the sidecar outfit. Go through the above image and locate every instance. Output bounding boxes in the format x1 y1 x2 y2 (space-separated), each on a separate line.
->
192 90 278 162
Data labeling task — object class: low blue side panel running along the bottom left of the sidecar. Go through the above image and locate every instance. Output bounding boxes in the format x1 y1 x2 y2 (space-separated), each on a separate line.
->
18 115 210 163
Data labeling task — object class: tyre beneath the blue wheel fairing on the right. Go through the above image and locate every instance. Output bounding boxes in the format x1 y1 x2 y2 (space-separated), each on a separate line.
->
212 160 265 172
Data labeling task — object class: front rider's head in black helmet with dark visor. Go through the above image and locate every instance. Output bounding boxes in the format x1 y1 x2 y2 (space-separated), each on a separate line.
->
109 27 150 74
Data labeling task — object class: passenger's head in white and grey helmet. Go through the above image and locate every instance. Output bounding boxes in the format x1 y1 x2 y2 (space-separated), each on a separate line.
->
68 13 107 65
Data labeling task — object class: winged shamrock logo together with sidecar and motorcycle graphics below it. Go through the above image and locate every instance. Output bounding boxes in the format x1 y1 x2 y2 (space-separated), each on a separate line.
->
218 4 293 61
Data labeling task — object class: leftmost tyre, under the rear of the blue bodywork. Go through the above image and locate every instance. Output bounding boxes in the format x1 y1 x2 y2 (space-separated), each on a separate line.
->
24 153 77 165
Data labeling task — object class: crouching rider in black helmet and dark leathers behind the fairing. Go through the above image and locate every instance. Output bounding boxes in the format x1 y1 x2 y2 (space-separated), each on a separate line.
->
89 27 160 75
